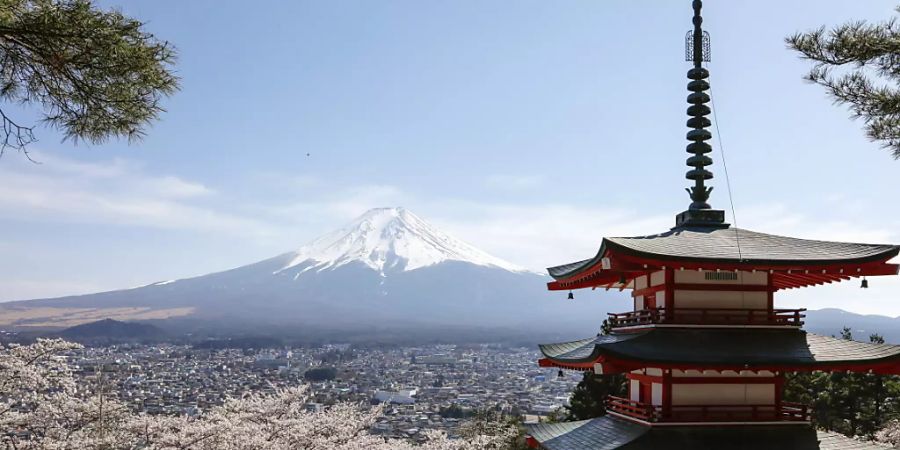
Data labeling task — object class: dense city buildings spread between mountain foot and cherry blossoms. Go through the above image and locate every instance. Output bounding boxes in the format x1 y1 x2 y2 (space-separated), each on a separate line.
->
68 344 568 440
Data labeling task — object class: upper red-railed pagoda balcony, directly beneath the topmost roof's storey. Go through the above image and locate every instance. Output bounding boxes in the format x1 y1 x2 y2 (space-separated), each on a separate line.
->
609 308 806 328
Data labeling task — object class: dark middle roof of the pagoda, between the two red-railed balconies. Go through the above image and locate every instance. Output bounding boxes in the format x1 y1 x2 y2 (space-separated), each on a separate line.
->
540 328 900 372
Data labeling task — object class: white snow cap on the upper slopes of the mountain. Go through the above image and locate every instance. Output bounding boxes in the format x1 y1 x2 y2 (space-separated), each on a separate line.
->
276 208 525 275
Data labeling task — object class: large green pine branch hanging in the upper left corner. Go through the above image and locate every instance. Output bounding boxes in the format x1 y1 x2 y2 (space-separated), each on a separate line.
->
0 0 178 154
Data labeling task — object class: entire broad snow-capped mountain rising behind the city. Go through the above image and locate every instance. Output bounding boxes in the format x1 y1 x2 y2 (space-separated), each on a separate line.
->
0 208 622 334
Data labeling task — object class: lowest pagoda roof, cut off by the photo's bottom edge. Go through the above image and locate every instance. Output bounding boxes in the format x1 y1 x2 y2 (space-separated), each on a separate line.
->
527 415 890 450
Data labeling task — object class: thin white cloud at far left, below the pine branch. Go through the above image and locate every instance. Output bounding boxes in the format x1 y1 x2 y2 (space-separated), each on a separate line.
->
0 152 277 237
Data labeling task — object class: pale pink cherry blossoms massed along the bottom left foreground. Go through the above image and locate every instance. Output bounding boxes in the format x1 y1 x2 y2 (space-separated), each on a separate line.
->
0 340 518 450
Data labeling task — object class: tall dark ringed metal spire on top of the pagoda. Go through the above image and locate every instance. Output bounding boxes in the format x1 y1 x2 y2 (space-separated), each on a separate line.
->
676 0 727 226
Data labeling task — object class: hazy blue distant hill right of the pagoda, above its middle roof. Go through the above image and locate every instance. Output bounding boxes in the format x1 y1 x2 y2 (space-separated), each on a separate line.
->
804 308 900 344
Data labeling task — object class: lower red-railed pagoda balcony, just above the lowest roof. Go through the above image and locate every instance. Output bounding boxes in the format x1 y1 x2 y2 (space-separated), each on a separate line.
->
606 396 810 424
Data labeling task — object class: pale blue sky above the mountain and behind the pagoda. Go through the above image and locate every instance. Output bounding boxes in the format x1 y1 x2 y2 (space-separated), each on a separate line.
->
0 0 900 315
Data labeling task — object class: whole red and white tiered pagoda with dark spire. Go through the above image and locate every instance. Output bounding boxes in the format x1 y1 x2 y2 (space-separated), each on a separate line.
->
528 0 900 450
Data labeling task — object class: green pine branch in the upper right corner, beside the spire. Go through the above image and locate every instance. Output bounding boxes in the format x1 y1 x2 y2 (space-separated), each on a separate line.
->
786 8 900 159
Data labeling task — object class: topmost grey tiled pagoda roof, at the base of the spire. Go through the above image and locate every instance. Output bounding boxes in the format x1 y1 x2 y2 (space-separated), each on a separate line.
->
547 227 900 280
